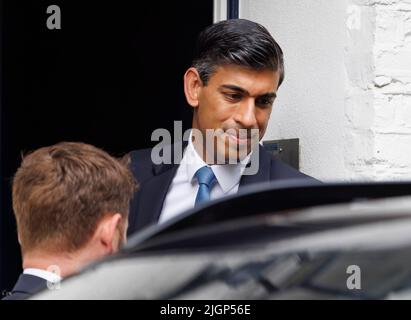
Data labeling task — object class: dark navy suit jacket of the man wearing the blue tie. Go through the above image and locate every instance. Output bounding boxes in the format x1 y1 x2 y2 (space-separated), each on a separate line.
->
128 145 316 235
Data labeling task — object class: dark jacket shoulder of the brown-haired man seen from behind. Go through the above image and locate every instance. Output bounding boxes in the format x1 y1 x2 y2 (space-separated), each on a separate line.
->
3 273 47 300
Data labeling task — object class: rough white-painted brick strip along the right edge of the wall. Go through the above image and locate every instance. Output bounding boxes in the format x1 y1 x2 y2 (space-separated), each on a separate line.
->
369 0 411 180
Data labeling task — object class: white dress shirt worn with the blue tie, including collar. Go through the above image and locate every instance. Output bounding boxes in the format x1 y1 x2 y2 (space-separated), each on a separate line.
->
159 134 251 223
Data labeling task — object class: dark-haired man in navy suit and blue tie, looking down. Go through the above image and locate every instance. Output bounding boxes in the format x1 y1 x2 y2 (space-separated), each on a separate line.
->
129 19 315 233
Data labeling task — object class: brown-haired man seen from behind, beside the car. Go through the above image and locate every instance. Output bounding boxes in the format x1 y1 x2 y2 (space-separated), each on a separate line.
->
4 142 135 300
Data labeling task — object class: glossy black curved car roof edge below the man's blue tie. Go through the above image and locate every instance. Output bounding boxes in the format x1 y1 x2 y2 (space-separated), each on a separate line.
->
125 179 411 251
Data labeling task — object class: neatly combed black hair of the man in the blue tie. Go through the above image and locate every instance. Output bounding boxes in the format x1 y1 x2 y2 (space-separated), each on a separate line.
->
192 19 284 86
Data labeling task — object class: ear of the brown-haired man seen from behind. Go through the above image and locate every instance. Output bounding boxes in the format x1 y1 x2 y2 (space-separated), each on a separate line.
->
98 213 123 254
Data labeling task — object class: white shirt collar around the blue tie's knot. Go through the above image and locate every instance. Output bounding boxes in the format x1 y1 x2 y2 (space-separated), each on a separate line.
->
184 133 251 193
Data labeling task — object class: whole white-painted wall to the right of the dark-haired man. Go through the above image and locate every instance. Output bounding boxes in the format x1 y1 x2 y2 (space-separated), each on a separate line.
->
240 0 411 180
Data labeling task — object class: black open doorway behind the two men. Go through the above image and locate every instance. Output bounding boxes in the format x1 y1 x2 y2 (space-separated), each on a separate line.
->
0 0 213 290
